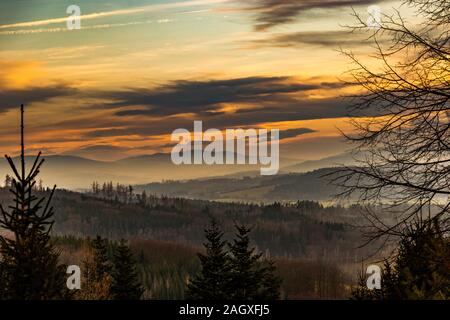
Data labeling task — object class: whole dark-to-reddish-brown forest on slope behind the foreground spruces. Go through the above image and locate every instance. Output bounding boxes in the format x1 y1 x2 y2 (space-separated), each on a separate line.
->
0 179 376 299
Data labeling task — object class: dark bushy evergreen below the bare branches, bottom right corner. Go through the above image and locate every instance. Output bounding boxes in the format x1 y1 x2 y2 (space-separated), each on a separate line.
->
352 220 450 300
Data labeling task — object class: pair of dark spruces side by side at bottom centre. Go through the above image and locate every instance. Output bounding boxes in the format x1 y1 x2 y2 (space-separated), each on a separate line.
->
186 219 281 300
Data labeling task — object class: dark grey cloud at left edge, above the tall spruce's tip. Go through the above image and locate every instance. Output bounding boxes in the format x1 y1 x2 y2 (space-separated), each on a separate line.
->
0 85 77 112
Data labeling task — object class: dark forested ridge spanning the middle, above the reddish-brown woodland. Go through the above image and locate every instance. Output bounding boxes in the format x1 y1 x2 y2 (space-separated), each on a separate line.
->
0 188 370 261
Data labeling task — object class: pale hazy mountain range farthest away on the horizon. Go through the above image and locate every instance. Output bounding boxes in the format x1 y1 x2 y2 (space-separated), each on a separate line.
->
0 153 298 190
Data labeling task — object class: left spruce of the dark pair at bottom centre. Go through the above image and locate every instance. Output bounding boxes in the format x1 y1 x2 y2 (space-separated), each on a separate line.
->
186 219 230 300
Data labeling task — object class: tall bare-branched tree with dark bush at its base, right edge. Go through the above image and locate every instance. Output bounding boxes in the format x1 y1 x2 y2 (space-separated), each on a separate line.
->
335 0 450 299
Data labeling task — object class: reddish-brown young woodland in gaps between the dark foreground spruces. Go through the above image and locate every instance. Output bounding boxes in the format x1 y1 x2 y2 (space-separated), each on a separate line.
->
54 232 355 300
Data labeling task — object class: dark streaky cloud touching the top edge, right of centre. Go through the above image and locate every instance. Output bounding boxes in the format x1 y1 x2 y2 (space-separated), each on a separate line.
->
247 0 380 31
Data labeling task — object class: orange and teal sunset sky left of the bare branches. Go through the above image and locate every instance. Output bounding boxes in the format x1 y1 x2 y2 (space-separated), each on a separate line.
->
0 0 408 160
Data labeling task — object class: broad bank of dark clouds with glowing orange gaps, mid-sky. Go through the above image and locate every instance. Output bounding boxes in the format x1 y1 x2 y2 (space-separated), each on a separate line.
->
67 77 351 140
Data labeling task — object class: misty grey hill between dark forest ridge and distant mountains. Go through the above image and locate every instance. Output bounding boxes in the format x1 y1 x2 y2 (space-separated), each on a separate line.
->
135 168 339 202
